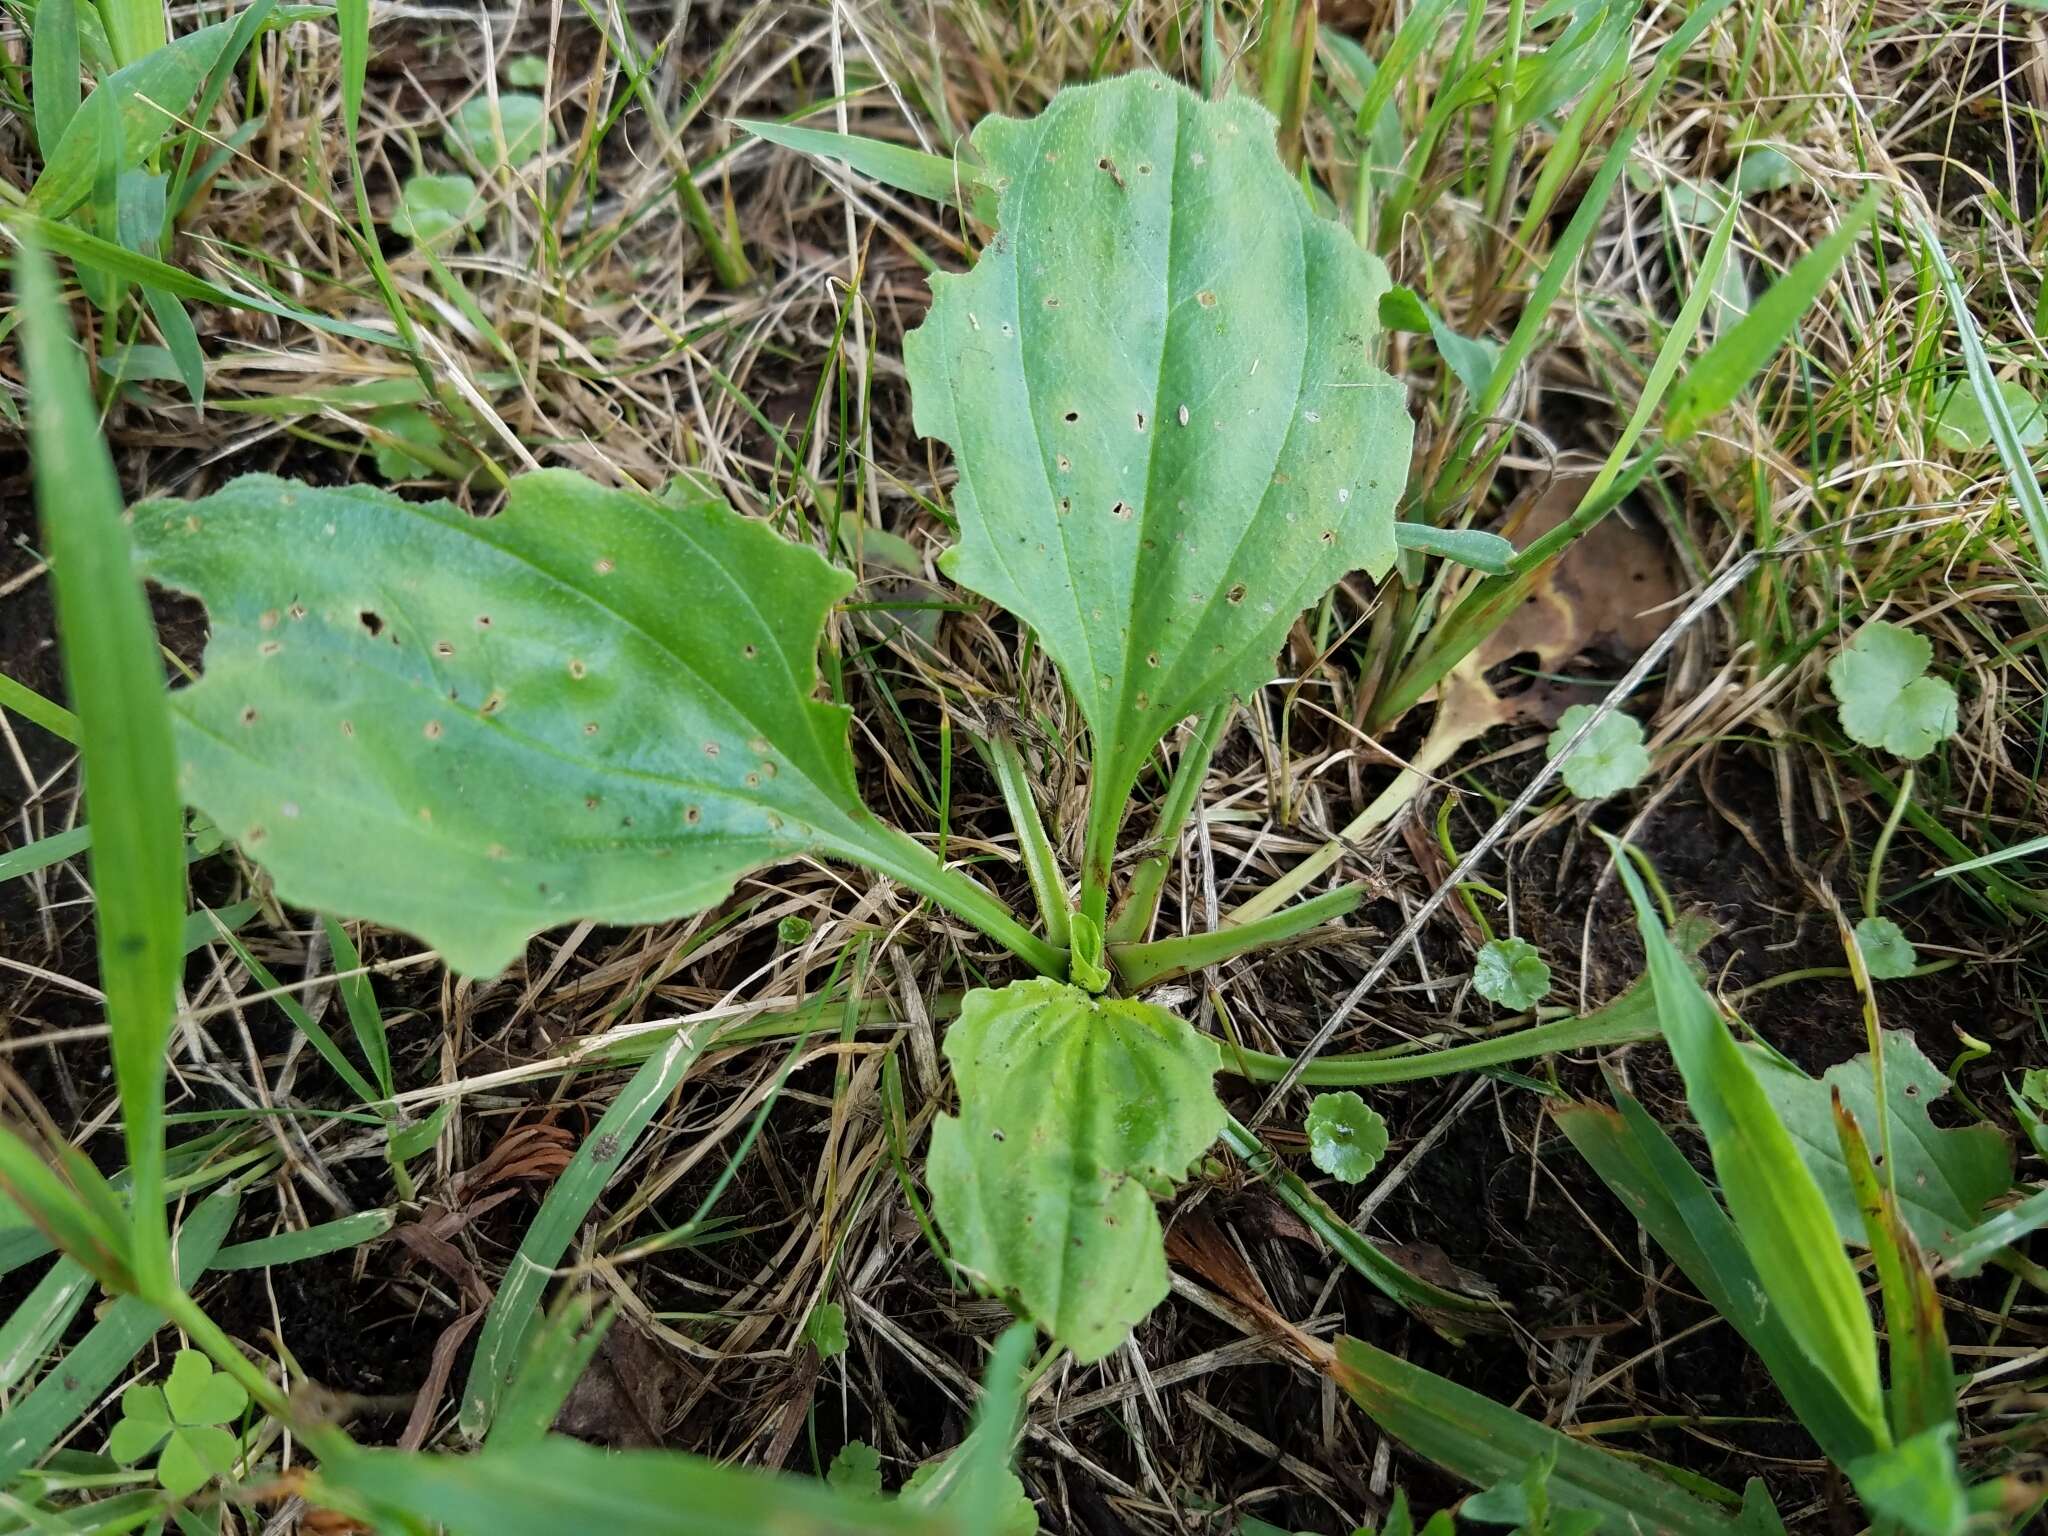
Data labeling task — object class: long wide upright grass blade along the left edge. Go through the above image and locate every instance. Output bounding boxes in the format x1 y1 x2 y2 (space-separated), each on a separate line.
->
16 248 184 1290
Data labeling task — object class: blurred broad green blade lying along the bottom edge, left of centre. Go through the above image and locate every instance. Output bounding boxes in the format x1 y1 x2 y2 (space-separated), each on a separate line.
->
309 1436 967 1536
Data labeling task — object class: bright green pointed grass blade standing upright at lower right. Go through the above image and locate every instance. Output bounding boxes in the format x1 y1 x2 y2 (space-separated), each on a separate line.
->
1616 846 1886 1444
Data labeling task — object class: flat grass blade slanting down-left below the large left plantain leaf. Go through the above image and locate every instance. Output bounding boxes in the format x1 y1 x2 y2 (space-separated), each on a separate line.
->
461 1032 705 1440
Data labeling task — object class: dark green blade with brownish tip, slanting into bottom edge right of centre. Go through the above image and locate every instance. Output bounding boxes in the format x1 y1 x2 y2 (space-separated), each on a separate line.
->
1331 1337 1745 1536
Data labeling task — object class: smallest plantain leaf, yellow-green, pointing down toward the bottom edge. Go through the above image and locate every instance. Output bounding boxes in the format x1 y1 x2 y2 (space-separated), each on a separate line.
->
926 979 1225 1360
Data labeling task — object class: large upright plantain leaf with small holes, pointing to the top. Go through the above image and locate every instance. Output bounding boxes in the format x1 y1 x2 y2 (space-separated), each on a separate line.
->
903 74 1411 795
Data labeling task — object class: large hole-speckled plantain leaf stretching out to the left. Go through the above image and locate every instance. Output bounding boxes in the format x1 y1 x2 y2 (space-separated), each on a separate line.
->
135 471 909 975
